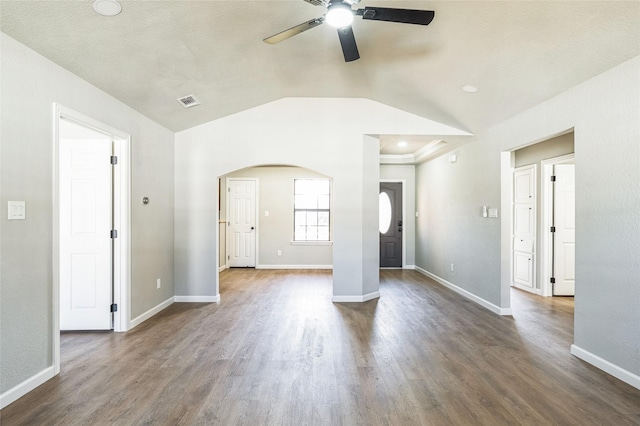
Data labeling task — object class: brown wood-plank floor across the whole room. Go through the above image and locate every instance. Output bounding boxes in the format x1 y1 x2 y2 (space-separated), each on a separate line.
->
0 269 640 426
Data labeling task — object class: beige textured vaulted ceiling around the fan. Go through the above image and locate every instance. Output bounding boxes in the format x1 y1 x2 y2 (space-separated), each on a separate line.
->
0 0 640 154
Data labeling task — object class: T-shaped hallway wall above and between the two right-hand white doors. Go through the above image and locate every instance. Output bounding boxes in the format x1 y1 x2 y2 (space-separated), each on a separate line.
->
513 132 574 290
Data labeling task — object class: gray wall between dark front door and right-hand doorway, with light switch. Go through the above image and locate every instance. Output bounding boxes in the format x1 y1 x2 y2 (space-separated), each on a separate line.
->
416 136 501 306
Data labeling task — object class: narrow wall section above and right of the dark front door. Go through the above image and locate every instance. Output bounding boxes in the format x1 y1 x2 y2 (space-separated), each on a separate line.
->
380 164 416 268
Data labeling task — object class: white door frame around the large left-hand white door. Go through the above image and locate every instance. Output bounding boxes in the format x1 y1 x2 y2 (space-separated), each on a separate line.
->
52 103 131 374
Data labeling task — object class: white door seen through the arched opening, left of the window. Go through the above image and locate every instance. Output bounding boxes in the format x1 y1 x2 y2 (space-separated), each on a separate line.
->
227 179 256 267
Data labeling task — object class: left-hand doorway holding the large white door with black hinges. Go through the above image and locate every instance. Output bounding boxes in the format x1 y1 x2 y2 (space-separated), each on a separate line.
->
52 104 130 374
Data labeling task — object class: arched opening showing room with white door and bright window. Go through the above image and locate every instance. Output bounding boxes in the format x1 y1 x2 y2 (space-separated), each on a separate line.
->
216 164 333 300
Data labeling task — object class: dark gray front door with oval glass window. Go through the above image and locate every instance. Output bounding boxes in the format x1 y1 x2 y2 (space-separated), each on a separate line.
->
380 182 402 268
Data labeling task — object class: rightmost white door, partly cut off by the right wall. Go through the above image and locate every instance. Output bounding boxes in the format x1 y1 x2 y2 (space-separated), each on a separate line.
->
553 164 576 296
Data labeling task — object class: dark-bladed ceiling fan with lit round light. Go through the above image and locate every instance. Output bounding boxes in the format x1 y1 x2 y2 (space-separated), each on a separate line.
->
264 0 435 62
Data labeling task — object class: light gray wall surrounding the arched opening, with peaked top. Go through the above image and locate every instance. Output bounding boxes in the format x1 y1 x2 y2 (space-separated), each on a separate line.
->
175 98 448 301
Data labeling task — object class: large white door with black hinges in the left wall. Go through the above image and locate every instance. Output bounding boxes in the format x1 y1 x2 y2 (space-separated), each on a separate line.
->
59 133 112 330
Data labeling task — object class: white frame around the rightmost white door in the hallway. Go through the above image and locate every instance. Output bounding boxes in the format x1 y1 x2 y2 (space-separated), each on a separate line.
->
540 154 575 297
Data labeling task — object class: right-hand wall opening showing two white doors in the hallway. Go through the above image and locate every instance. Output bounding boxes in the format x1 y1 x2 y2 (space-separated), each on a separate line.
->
503 129 575 302
